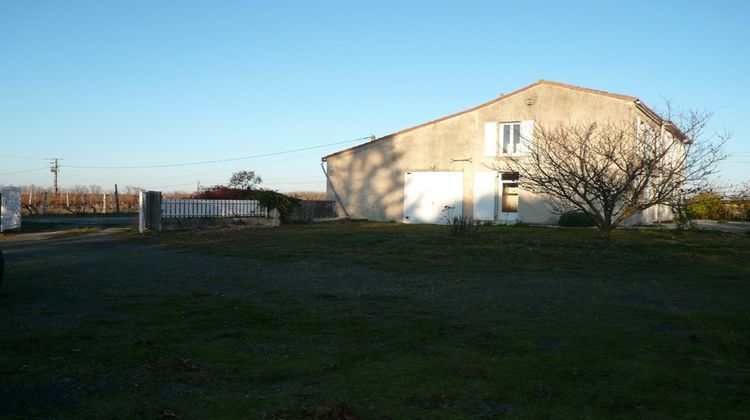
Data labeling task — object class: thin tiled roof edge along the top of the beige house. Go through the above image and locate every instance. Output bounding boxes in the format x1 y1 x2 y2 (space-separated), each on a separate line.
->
322 79 686 161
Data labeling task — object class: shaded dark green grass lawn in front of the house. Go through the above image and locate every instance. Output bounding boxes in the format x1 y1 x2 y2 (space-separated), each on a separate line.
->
0 222 750 418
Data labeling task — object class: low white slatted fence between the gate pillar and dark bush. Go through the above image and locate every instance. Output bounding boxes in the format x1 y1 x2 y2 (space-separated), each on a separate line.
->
161 199 268 217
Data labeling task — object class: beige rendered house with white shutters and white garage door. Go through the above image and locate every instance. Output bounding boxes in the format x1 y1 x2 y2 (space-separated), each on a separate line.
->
322 80 672 224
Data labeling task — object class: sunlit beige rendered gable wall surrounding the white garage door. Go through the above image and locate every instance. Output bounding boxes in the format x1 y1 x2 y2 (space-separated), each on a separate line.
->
327 84 641 223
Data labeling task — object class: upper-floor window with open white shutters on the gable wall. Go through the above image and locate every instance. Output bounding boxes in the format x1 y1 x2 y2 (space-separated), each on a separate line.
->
484 121 534 156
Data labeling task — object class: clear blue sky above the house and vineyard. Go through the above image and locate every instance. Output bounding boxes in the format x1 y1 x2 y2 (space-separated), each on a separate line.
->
0 0 750 191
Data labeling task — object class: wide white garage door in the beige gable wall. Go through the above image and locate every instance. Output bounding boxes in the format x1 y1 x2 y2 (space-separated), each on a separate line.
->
404 172 464 223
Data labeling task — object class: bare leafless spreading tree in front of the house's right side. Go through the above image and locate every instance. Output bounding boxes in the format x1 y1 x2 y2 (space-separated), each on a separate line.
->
492 107 730 239
